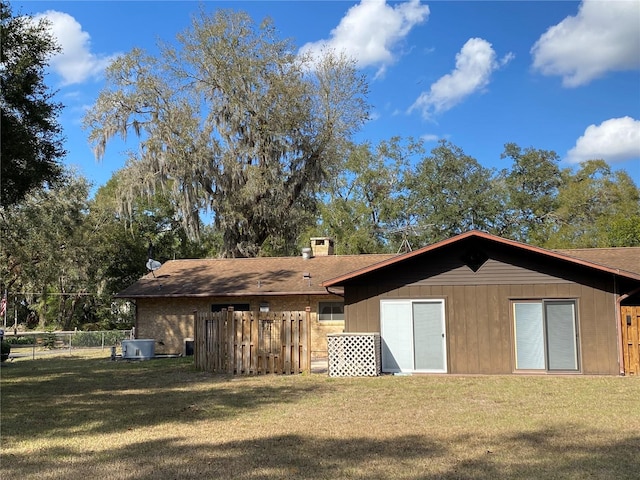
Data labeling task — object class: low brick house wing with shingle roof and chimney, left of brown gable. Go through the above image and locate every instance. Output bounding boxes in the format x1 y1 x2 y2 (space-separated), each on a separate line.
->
116 237 394 357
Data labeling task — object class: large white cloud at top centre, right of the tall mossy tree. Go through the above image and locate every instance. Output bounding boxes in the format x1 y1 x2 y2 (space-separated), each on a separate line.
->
300 0 429 75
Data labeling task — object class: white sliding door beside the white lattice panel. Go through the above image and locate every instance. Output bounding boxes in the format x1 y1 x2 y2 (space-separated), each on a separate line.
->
380 300 447 373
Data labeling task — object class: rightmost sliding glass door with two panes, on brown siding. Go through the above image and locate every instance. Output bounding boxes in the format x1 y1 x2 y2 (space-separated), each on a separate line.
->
513 300 579 371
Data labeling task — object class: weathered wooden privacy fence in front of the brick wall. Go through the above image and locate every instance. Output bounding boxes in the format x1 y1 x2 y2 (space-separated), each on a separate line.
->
194 309 311 375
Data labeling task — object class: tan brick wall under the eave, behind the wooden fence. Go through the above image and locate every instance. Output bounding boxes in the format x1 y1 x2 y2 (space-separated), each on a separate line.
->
136 295 344 358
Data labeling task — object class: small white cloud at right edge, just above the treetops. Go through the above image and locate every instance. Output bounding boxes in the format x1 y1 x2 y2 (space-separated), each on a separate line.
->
567 117 640 163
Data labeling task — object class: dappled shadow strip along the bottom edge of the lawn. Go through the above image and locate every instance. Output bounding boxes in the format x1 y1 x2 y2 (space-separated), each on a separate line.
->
3 431 640 480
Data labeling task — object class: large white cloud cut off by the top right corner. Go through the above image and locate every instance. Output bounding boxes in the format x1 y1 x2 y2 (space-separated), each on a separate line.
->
531 0 640 87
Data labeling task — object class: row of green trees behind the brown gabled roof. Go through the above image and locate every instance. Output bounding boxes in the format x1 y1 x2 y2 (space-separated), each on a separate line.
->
318 138 640 254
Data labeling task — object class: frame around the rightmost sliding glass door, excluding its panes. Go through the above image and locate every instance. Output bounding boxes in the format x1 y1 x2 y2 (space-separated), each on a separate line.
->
510 298 582 374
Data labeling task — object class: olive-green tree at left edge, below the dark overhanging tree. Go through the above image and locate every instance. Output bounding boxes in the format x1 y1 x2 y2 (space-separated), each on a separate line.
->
0 172 93 329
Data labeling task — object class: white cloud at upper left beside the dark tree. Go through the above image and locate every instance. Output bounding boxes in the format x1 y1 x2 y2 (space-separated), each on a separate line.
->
34 10 118 85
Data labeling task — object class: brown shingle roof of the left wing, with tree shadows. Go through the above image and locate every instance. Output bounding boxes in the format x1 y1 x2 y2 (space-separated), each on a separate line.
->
116 254 395 298
